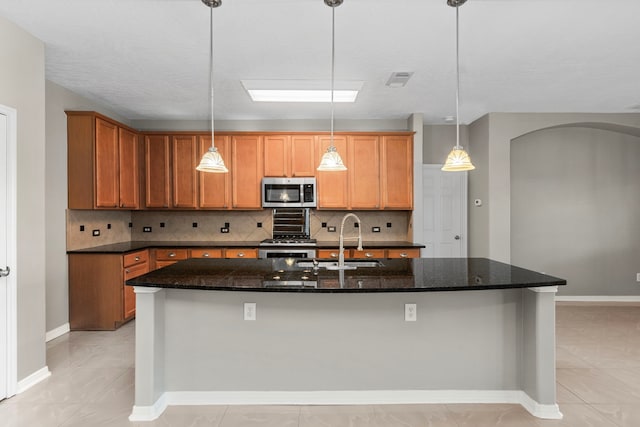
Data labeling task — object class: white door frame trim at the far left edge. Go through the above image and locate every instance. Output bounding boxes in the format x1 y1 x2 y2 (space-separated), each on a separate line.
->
0 104 18 398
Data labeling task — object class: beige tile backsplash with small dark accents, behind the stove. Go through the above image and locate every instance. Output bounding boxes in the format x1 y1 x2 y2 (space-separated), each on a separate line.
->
67 209 411 250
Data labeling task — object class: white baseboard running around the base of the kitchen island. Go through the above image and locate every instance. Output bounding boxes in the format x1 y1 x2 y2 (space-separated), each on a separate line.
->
129 390 562 421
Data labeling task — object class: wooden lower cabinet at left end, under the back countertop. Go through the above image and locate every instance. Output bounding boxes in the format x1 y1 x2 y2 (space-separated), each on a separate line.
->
69 249 149 331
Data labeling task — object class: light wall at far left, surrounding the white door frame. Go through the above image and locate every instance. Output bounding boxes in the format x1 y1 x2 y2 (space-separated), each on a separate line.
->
0 17 46 381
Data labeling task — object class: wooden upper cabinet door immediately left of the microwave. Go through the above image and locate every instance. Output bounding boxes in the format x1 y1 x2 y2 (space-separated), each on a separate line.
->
231 135 263 209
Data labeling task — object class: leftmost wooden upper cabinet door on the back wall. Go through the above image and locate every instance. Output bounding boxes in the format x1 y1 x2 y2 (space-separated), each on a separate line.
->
144 135 170 208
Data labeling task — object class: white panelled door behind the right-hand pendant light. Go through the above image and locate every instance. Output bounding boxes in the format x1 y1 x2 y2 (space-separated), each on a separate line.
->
422 165 467 258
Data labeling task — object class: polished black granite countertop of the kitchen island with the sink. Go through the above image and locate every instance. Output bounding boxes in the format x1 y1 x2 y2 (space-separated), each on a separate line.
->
127 258 566 293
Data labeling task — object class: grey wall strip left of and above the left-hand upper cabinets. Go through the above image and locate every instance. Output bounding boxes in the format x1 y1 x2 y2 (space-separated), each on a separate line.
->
45 81 127 331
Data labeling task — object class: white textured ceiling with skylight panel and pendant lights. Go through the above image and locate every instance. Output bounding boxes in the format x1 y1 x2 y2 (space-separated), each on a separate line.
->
0 0 640 123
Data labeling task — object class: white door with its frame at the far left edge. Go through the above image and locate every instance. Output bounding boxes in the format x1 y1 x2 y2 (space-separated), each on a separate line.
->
0 105 17 400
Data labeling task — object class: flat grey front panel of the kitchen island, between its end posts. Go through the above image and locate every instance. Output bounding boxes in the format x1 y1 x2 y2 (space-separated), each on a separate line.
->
162 289 522 392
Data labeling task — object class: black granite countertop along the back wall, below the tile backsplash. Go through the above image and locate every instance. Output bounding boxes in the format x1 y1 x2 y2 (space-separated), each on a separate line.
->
67 240 425 254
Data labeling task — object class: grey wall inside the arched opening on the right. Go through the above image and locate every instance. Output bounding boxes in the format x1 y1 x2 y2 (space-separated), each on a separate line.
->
511 127 640 296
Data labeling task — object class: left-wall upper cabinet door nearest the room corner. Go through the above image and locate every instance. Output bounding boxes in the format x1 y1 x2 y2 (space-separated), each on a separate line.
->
118 128 140 209
